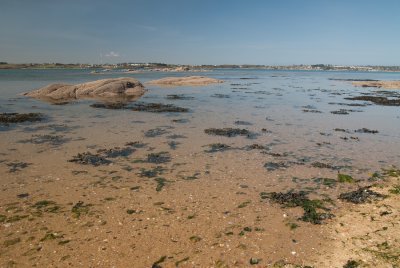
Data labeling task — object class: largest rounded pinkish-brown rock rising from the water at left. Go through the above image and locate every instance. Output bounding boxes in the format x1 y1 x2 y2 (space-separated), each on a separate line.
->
22 77 146 104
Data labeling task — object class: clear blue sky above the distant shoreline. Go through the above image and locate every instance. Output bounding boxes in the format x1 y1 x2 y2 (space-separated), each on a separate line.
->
0 0 400 65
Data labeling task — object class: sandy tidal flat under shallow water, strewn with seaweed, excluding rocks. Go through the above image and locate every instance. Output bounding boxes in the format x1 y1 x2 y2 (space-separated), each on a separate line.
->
0 69 400 267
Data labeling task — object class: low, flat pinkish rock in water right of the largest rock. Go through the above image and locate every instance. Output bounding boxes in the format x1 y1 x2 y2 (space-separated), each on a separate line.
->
148 76 224 86
